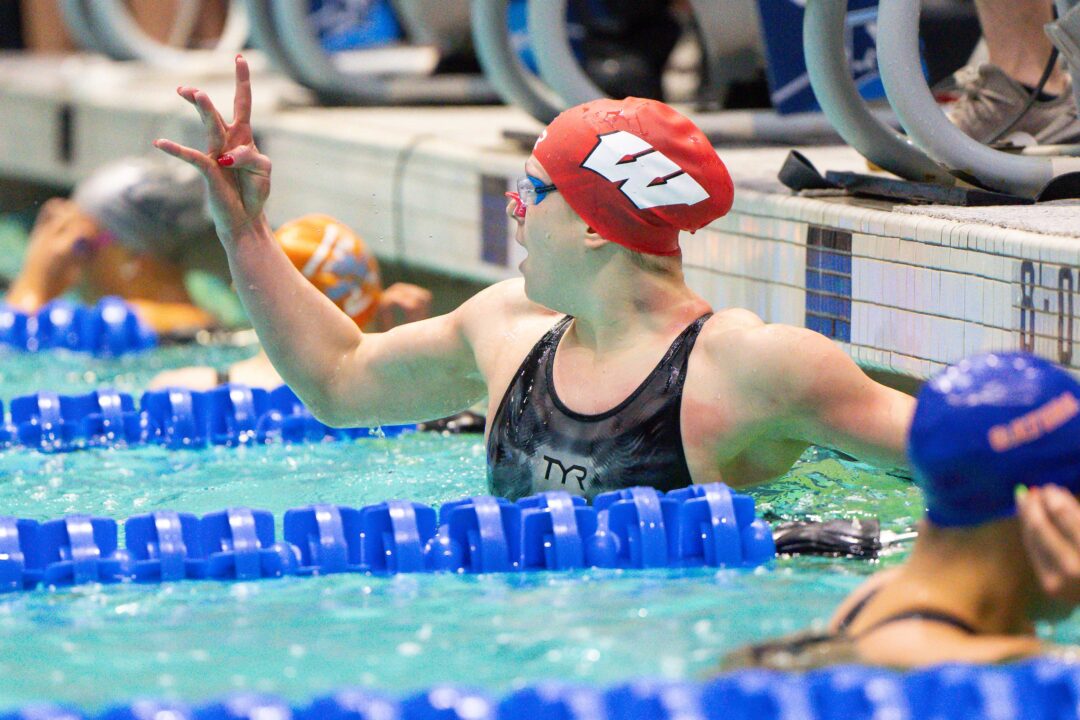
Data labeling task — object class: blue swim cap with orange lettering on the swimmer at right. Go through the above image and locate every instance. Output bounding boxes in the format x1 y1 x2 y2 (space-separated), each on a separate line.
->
907 353 1080 527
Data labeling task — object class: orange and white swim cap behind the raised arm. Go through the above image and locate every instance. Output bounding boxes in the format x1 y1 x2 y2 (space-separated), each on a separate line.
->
274 215 382 326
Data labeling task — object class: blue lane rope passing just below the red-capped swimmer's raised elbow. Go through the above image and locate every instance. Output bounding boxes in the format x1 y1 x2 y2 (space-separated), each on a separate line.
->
0 384 416 452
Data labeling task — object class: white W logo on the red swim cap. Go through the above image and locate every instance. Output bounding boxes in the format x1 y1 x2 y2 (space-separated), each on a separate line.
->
581 130 708 210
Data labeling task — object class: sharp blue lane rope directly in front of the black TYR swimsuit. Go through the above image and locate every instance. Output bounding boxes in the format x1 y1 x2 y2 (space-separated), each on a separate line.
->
0 484 775 593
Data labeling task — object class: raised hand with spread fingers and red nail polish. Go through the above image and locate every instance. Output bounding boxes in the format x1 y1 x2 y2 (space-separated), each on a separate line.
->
153 55 270 244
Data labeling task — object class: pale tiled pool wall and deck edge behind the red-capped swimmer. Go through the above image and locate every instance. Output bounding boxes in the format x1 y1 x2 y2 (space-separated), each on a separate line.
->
0 55 1080 378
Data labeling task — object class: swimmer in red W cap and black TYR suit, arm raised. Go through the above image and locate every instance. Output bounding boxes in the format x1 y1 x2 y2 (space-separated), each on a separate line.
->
154 57 914 498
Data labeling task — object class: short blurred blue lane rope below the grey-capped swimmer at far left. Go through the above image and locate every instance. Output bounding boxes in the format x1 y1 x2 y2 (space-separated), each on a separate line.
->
0 298 158 356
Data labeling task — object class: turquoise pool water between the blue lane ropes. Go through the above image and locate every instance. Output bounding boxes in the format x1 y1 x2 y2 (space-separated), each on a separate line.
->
0 321 1080 709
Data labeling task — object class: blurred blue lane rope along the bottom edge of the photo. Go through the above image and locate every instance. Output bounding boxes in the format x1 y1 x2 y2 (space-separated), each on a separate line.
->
6 658 1080 720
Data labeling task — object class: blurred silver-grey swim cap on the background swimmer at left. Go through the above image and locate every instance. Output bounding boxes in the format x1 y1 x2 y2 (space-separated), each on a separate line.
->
72 157 217 263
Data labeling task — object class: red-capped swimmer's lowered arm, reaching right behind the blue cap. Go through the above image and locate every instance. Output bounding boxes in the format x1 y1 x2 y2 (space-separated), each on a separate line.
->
748 325 915 467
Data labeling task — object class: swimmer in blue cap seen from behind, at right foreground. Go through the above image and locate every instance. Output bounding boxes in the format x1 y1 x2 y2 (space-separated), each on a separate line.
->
726 353 1080 669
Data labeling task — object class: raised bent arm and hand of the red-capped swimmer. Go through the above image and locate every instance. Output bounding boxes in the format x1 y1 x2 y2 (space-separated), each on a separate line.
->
153 55 484 425
